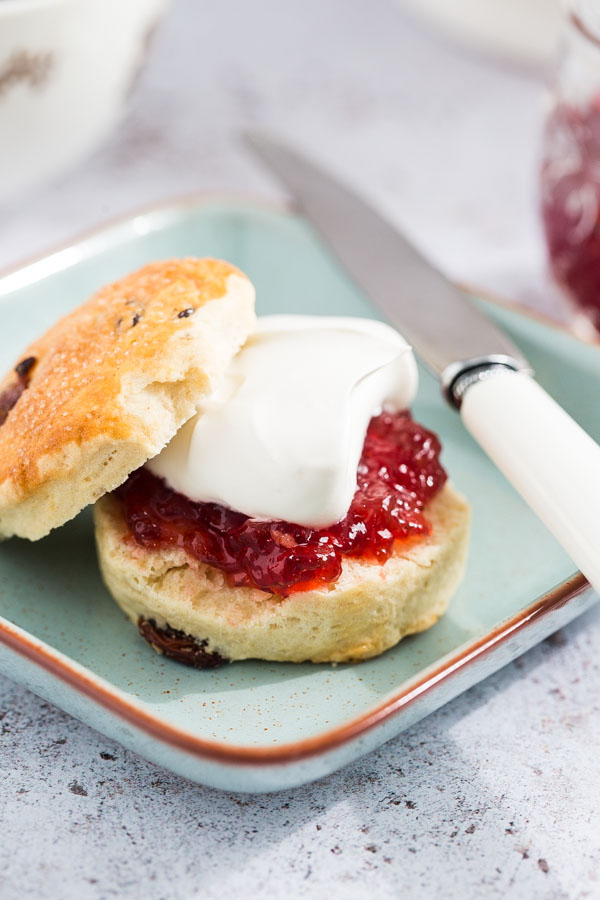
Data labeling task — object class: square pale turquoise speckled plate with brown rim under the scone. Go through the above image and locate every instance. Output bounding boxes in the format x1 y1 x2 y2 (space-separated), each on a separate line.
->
0 198 600 791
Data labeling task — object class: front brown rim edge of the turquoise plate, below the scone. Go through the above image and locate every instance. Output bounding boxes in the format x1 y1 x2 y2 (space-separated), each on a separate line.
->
0 572 589 765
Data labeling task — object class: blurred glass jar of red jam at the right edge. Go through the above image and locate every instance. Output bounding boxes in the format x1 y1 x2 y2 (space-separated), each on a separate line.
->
541 0 600 337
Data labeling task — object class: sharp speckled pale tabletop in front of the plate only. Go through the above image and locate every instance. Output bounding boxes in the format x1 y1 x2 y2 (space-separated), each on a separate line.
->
0 611 600 900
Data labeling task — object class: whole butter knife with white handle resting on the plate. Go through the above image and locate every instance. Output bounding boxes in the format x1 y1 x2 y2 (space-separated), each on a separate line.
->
246 126 600 591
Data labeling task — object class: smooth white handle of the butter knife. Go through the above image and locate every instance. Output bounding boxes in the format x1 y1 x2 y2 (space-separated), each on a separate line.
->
460 369 600 592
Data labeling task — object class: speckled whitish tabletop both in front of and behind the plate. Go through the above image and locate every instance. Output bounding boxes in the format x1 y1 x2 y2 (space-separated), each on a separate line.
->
0 0 600 900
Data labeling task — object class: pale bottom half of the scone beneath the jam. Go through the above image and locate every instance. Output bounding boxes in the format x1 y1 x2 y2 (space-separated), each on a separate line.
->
94 484 470 662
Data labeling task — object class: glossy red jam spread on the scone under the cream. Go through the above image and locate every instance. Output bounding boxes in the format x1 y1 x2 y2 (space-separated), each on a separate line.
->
116 412 446 597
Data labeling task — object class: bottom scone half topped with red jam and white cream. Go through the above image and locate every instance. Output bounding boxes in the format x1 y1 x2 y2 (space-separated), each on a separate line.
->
95 316 470 668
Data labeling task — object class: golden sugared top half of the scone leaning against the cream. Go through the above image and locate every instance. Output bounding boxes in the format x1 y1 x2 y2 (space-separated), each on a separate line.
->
0 259 254 540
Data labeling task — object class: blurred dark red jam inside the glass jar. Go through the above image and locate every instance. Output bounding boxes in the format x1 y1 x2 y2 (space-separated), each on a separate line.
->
542 96 600 331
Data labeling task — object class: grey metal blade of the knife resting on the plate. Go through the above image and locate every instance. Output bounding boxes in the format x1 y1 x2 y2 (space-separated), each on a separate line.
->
247 132 529 400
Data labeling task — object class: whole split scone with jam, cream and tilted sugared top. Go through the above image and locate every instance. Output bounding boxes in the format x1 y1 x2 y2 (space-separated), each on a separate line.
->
0 259 469 668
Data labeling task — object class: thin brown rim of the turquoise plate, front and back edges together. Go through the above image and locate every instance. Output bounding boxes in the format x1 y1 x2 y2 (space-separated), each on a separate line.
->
0 191 596 766
